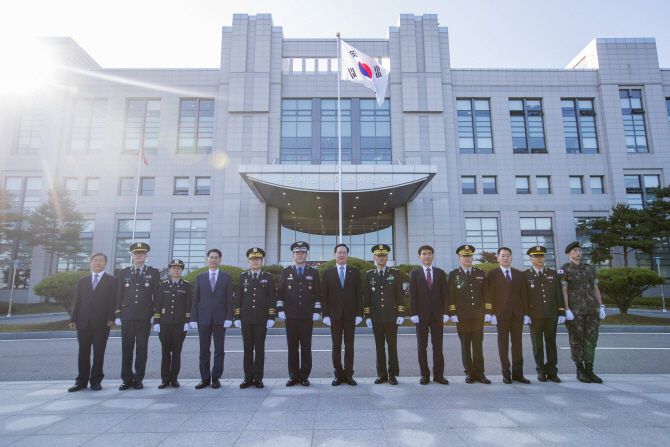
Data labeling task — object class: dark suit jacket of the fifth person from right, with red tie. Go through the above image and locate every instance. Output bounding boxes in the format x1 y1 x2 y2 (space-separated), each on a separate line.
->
409 267 449 322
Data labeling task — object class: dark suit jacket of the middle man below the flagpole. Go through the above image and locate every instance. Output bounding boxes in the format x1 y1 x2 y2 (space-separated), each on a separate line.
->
321 264 363 321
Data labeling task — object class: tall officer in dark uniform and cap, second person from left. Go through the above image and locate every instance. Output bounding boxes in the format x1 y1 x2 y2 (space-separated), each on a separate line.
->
115 242 160 391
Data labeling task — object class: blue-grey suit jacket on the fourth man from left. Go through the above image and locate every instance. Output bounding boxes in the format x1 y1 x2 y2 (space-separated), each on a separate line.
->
191 269 233 326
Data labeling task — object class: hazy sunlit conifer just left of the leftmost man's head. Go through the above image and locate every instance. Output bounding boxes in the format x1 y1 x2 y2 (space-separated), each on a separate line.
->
17 184 83 275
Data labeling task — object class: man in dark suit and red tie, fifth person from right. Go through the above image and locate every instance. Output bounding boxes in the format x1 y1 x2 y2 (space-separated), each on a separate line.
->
409 245 449 385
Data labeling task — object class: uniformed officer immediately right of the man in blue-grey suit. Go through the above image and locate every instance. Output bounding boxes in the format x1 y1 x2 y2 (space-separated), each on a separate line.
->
233 247 277 389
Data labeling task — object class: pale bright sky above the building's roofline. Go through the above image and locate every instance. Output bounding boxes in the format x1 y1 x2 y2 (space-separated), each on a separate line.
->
5 0 670 68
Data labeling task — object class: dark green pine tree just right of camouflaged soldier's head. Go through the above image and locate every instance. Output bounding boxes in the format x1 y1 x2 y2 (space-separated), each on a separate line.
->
590 203 658 267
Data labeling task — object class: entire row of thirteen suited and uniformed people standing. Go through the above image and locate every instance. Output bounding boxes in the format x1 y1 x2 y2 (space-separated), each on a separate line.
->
69 241 605 391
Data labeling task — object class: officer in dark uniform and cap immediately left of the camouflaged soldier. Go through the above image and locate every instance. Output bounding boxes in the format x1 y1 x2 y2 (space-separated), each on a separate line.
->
523 245 565 383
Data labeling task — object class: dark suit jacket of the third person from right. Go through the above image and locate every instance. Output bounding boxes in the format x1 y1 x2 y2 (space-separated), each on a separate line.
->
486 267 528 320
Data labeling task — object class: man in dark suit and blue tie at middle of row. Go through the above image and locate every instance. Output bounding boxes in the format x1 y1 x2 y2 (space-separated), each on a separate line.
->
321 244 363 386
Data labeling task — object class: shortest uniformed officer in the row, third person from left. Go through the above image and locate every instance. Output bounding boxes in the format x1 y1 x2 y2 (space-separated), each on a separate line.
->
154 259 193 390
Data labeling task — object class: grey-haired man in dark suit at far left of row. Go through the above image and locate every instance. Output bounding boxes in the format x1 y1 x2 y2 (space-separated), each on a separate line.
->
68 253 117 392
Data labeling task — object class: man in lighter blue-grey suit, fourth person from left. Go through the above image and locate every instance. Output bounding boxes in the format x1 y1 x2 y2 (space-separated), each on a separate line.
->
190 248 233 390
